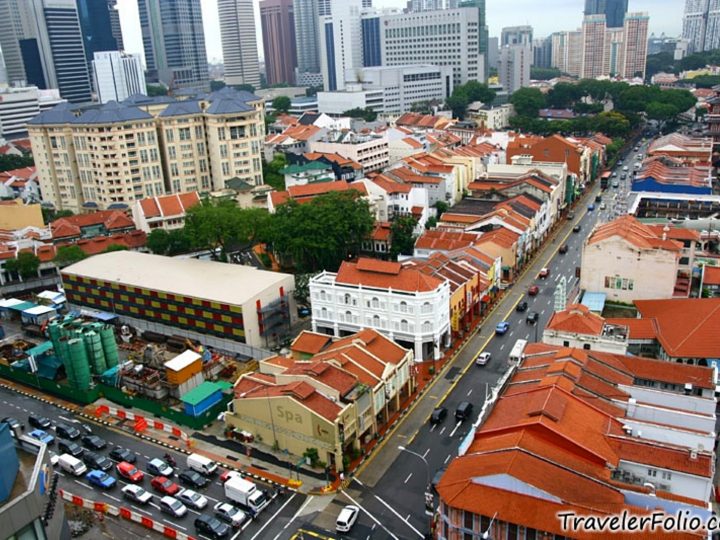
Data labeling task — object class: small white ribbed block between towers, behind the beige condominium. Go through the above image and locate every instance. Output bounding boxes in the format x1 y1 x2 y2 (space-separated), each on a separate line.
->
92 51 147 103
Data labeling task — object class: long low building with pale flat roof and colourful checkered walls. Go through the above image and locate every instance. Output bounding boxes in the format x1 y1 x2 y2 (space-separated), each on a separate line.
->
62 251 296 357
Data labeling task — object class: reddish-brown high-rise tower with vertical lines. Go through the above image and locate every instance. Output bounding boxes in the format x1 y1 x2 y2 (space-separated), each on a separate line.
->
260 0 297 84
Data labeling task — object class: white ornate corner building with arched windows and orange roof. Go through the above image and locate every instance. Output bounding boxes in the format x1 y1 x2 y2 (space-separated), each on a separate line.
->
310 258 450 360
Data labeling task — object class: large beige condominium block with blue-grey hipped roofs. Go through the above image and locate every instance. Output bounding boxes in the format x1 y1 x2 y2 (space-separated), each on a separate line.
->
28 88 265 212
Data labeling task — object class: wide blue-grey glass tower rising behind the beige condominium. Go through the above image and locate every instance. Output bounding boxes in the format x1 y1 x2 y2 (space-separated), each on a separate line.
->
138 0 210 88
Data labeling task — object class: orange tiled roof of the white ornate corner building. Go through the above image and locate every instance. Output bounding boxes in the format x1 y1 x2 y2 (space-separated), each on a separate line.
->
336 258 443 292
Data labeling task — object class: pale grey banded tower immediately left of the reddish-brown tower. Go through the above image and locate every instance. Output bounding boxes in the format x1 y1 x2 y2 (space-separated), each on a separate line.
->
218 0 260 88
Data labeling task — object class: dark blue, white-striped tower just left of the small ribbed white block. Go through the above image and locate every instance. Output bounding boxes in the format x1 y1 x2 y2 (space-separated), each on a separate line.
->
20 0 91 103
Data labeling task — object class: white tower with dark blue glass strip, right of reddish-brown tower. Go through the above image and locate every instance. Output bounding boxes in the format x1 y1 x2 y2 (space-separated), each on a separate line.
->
319 0 363 91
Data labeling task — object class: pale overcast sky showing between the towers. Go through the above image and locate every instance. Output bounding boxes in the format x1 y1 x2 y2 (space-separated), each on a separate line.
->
118 0 684 66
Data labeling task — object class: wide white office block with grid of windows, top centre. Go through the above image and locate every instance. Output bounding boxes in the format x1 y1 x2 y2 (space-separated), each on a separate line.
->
380 7 485 85
